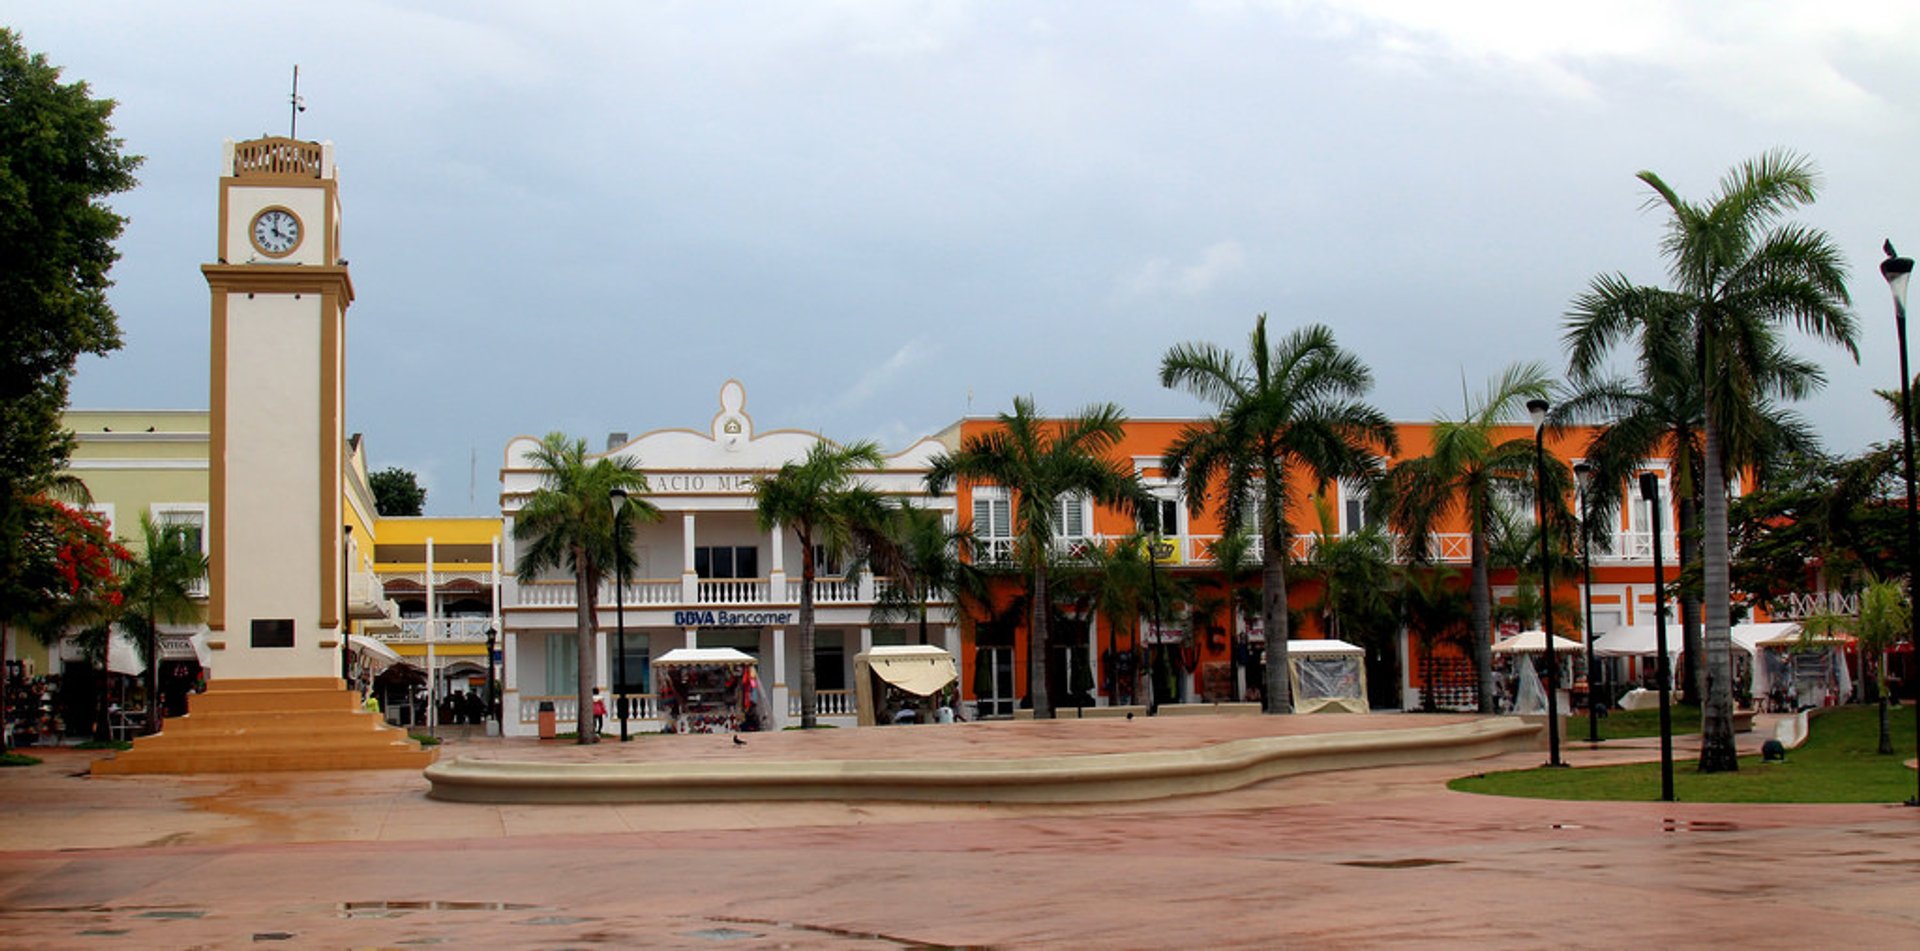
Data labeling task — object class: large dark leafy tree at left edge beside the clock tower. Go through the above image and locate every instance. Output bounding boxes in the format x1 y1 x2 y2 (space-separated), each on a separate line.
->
0 27 140 660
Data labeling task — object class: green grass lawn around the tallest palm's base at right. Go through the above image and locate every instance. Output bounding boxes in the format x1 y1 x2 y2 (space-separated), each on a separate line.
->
1448 705 1916 803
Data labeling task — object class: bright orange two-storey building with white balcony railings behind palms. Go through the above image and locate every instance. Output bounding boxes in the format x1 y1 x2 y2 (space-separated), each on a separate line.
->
948 417 1678 717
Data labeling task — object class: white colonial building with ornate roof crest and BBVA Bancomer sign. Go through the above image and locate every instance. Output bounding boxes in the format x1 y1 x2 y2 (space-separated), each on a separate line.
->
501 380 960 736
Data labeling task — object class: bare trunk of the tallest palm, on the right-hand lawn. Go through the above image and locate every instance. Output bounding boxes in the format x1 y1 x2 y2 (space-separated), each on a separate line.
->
1699 409 1740 772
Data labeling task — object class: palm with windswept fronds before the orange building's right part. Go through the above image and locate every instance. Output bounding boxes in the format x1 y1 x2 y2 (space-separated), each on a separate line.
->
1390 363 1551 713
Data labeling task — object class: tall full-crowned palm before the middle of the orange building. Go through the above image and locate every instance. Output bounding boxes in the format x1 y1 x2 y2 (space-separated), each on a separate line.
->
1160 313 1400 713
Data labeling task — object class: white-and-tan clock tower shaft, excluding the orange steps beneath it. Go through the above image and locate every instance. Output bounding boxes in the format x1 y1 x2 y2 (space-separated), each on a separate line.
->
202 136 353 680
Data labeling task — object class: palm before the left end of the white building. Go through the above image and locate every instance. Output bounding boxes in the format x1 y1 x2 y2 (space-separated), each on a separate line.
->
513 432 659 744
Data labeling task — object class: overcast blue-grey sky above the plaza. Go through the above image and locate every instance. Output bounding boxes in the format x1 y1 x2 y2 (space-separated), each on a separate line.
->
15 0 1920 515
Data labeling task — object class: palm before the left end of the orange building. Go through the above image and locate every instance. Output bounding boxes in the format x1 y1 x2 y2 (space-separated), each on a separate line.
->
925 396 1146 719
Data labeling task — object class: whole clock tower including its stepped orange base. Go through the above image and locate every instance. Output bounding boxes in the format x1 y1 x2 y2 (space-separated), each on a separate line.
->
92 138 434 774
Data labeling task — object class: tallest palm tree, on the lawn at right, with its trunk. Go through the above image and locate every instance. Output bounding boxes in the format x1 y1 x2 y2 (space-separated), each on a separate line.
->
1565 152 1859 772
